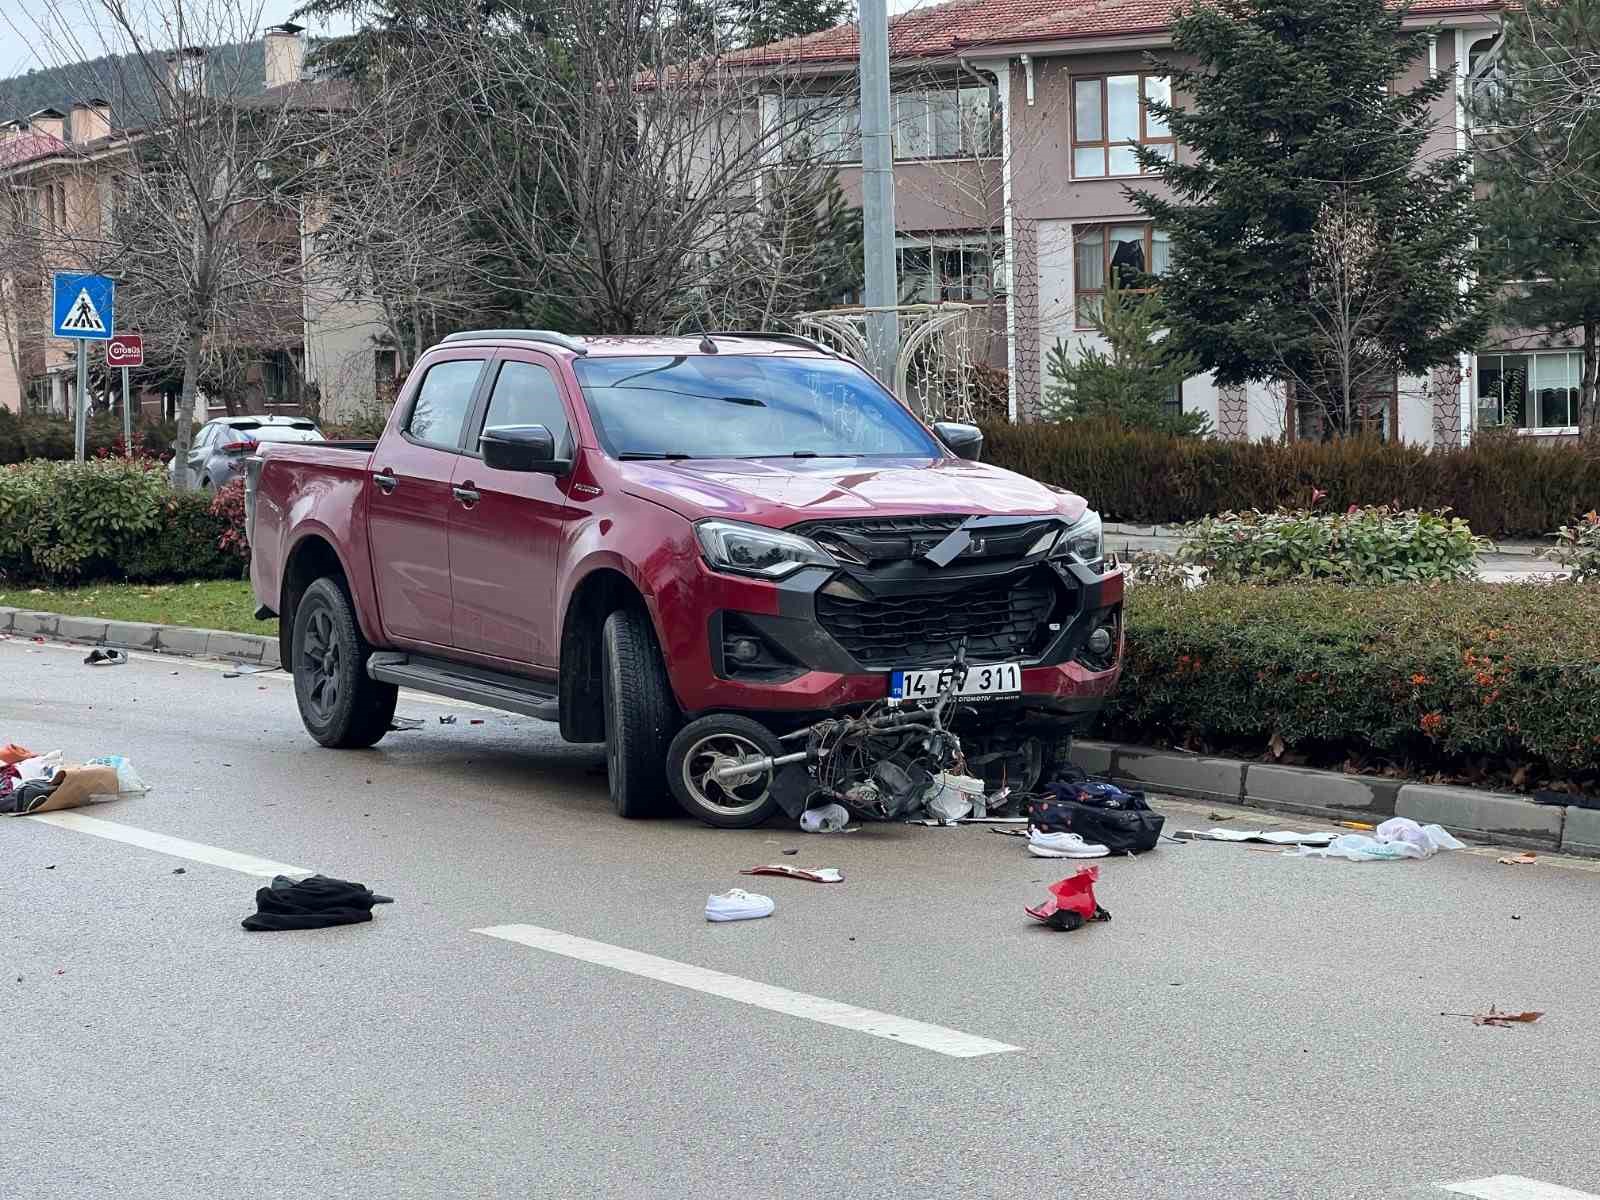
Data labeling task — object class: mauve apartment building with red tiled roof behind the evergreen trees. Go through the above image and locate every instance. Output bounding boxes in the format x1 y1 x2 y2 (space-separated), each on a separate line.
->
731 0 1536 445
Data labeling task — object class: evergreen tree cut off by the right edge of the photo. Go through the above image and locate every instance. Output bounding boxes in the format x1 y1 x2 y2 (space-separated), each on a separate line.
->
1472 0 1600 440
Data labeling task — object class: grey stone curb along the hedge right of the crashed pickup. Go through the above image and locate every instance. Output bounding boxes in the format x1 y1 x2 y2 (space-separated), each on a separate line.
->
1072 739 1600 858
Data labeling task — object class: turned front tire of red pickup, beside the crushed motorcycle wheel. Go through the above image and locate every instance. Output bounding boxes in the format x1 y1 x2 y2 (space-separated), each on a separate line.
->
600 608 678 821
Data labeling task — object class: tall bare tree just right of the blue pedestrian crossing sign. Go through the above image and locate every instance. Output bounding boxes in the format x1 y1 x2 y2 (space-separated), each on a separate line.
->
23 0 339 486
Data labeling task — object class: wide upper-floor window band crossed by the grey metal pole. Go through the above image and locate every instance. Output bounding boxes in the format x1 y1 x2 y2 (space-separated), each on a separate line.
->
779 86 1000 162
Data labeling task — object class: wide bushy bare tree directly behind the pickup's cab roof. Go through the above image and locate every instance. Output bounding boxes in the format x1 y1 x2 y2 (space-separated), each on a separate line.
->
374 0 857 333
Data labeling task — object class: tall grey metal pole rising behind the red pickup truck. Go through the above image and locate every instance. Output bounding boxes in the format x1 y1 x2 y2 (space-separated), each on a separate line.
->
861 0 899 400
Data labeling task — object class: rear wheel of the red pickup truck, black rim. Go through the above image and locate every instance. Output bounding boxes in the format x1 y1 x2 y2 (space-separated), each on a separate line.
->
291 578 400 750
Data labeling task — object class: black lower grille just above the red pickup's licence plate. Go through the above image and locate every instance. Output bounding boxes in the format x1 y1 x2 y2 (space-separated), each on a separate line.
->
816 568 1056 670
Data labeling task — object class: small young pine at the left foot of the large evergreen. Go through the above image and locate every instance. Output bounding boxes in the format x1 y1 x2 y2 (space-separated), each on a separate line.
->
1045 270 1211 435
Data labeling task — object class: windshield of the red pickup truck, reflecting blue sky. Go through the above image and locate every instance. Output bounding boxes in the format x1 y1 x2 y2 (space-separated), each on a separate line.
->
576 354 942 459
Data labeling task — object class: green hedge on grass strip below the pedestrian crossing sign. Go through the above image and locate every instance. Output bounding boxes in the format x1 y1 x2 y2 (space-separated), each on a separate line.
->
0 458 242 582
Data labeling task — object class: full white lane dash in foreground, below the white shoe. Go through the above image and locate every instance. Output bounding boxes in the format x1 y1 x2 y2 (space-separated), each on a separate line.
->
472 925 1021 1058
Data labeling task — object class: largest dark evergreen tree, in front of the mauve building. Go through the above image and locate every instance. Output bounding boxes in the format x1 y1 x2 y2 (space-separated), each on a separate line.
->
1130 0 1490 428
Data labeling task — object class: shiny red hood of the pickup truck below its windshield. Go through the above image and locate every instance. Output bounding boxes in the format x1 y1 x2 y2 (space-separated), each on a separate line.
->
616 458 1088 528
